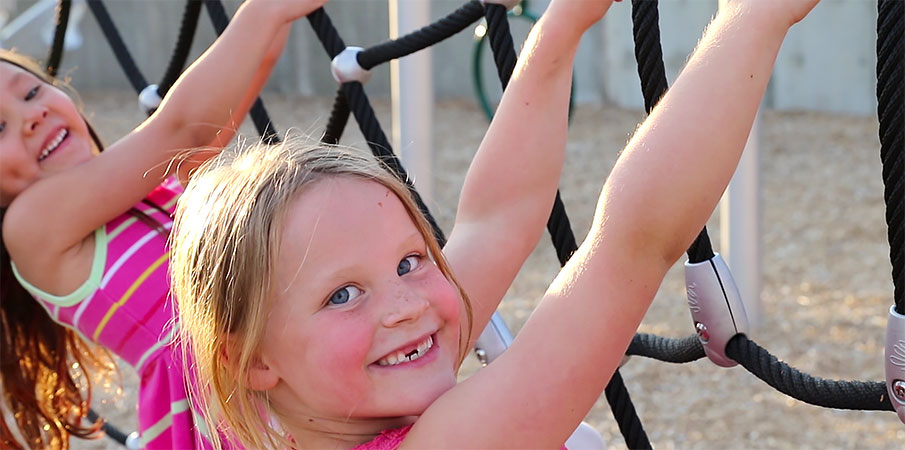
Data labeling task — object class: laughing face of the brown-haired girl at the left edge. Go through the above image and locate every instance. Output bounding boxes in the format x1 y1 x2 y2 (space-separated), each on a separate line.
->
0 62 94 206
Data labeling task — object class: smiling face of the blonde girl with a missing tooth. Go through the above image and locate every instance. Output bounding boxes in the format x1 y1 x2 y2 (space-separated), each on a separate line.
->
253 177 460 429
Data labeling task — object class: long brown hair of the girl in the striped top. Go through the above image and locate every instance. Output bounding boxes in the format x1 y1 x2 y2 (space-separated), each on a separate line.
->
0 49 168 448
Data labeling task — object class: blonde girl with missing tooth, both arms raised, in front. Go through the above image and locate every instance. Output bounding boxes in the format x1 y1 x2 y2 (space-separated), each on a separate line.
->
172 0 816 449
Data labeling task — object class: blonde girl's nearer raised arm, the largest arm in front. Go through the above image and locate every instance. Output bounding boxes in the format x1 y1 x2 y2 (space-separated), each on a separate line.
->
409 0 816 448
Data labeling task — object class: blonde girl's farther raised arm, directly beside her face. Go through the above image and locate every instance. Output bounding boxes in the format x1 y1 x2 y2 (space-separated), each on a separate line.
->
444 0 611 343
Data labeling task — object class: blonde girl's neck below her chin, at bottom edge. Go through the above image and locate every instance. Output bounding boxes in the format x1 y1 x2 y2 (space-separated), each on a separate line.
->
281 416 416 450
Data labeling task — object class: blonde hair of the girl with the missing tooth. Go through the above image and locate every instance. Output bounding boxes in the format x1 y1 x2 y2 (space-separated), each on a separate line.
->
170 137 472 448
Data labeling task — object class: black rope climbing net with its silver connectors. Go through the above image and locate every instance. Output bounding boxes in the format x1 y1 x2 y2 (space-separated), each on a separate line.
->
38 0 905 448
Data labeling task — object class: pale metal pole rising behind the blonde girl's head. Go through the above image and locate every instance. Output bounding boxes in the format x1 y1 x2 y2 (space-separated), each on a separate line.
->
388 0 434 205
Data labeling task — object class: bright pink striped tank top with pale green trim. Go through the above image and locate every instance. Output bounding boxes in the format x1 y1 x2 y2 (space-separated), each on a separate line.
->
14 178 221 449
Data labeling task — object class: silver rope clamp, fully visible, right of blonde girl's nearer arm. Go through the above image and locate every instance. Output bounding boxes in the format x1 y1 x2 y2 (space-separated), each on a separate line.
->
685 253 748 367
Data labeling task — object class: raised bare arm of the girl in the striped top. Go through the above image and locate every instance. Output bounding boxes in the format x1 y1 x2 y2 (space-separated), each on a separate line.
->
4 0 325 278
